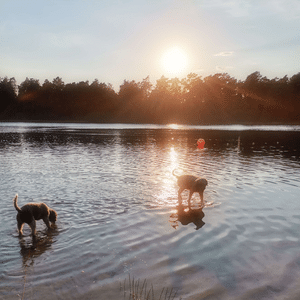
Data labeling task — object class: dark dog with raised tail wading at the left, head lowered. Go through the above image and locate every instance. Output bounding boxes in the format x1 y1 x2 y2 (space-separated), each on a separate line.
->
13 194 57 237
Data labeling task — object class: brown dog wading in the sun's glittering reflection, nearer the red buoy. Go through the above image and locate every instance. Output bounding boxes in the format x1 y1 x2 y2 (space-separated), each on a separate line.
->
172 170 208 208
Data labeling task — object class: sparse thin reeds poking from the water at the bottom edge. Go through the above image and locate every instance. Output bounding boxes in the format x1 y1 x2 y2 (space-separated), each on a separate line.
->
120 275 182 300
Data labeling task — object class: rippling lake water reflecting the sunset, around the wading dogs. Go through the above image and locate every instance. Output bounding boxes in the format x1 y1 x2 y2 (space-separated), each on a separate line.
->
0 123 300 300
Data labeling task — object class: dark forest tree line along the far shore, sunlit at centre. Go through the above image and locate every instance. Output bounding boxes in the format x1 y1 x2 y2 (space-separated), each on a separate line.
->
0 71 300 125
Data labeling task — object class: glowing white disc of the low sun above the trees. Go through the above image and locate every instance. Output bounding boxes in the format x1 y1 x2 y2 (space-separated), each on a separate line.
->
161 47 188 76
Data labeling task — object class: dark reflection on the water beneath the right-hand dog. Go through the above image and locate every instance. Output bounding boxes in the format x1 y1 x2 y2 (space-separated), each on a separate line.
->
170 205 205 230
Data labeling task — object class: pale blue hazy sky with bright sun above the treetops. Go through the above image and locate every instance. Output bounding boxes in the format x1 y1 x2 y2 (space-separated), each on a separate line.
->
0 0 300 91
